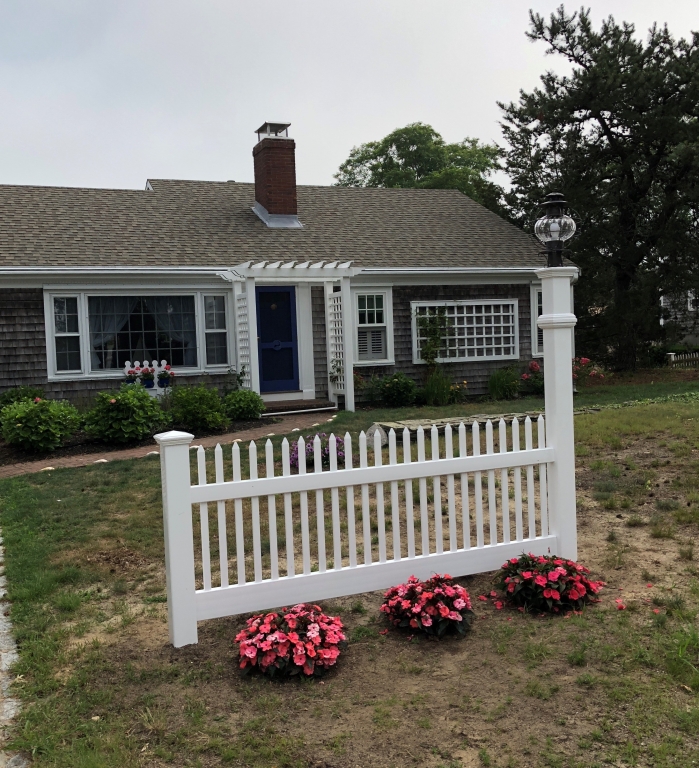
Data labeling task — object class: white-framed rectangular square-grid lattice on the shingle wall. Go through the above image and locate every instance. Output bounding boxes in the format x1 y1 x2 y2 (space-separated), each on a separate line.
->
411 299 519 363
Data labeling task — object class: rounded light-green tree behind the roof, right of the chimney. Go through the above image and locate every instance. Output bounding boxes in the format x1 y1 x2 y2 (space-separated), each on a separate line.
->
335 123 502 212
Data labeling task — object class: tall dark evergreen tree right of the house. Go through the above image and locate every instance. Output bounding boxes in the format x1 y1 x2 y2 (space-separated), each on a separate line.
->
499 6 699 368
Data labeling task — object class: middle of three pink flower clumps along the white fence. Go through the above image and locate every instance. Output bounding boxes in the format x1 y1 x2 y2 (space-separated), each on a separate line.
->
381 573 473 637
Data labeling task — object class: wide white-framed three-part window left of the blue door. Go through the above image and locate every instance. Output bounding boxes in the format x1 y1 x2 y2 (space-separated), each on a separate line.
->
46 291 229 376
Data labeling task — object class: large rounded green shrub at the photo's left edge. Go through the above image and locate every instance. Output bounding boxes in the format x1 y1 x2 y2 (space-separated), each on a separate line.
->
0 397 80 451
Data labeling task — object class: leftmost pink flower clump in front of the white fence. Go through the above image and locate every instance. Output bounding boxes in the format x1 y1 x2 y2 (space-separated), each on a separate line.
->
235 603 346 677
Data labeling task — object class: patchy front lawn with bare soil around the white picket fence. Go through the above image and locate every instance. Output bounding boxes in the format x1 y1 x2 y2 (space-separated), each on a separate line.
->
0 384 699 768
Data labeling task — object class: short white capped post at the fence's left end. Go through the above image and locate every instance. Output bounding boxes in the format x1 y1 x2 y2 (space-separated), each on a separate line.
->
155 431 197 648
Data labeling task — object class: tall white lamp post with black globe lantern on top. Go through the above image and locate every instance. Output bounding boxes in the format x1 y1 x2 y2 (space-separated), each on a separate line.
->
534 192 578 560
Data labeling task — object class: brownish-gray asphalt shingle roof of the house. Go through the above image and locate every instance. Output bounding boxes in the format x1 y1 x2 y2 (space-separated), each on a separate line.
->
0 180 543 269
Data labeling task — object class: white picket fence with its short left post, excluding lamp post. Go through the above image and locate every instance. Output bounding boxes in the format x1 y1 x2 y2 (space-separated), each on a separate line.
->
156 416 557 646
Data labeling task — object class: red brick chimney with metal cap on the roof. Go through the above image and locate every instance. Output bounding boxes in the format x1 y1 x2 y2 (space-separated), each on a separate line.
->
252 123 303 229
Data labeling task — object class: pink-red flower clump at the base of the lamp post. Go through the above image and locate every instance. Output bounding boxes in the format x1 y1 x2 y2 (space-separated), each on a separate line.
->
498 553 604 613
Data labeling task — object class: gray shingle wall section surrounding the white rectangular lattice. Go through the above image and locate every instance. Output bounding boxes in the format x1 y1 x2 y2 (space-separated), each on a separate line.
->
357 285 531 401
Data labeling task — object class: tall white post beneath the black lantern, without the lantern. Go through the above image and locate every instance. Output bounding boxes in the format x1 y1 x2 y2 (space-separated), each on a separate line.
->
536 267 578 560
